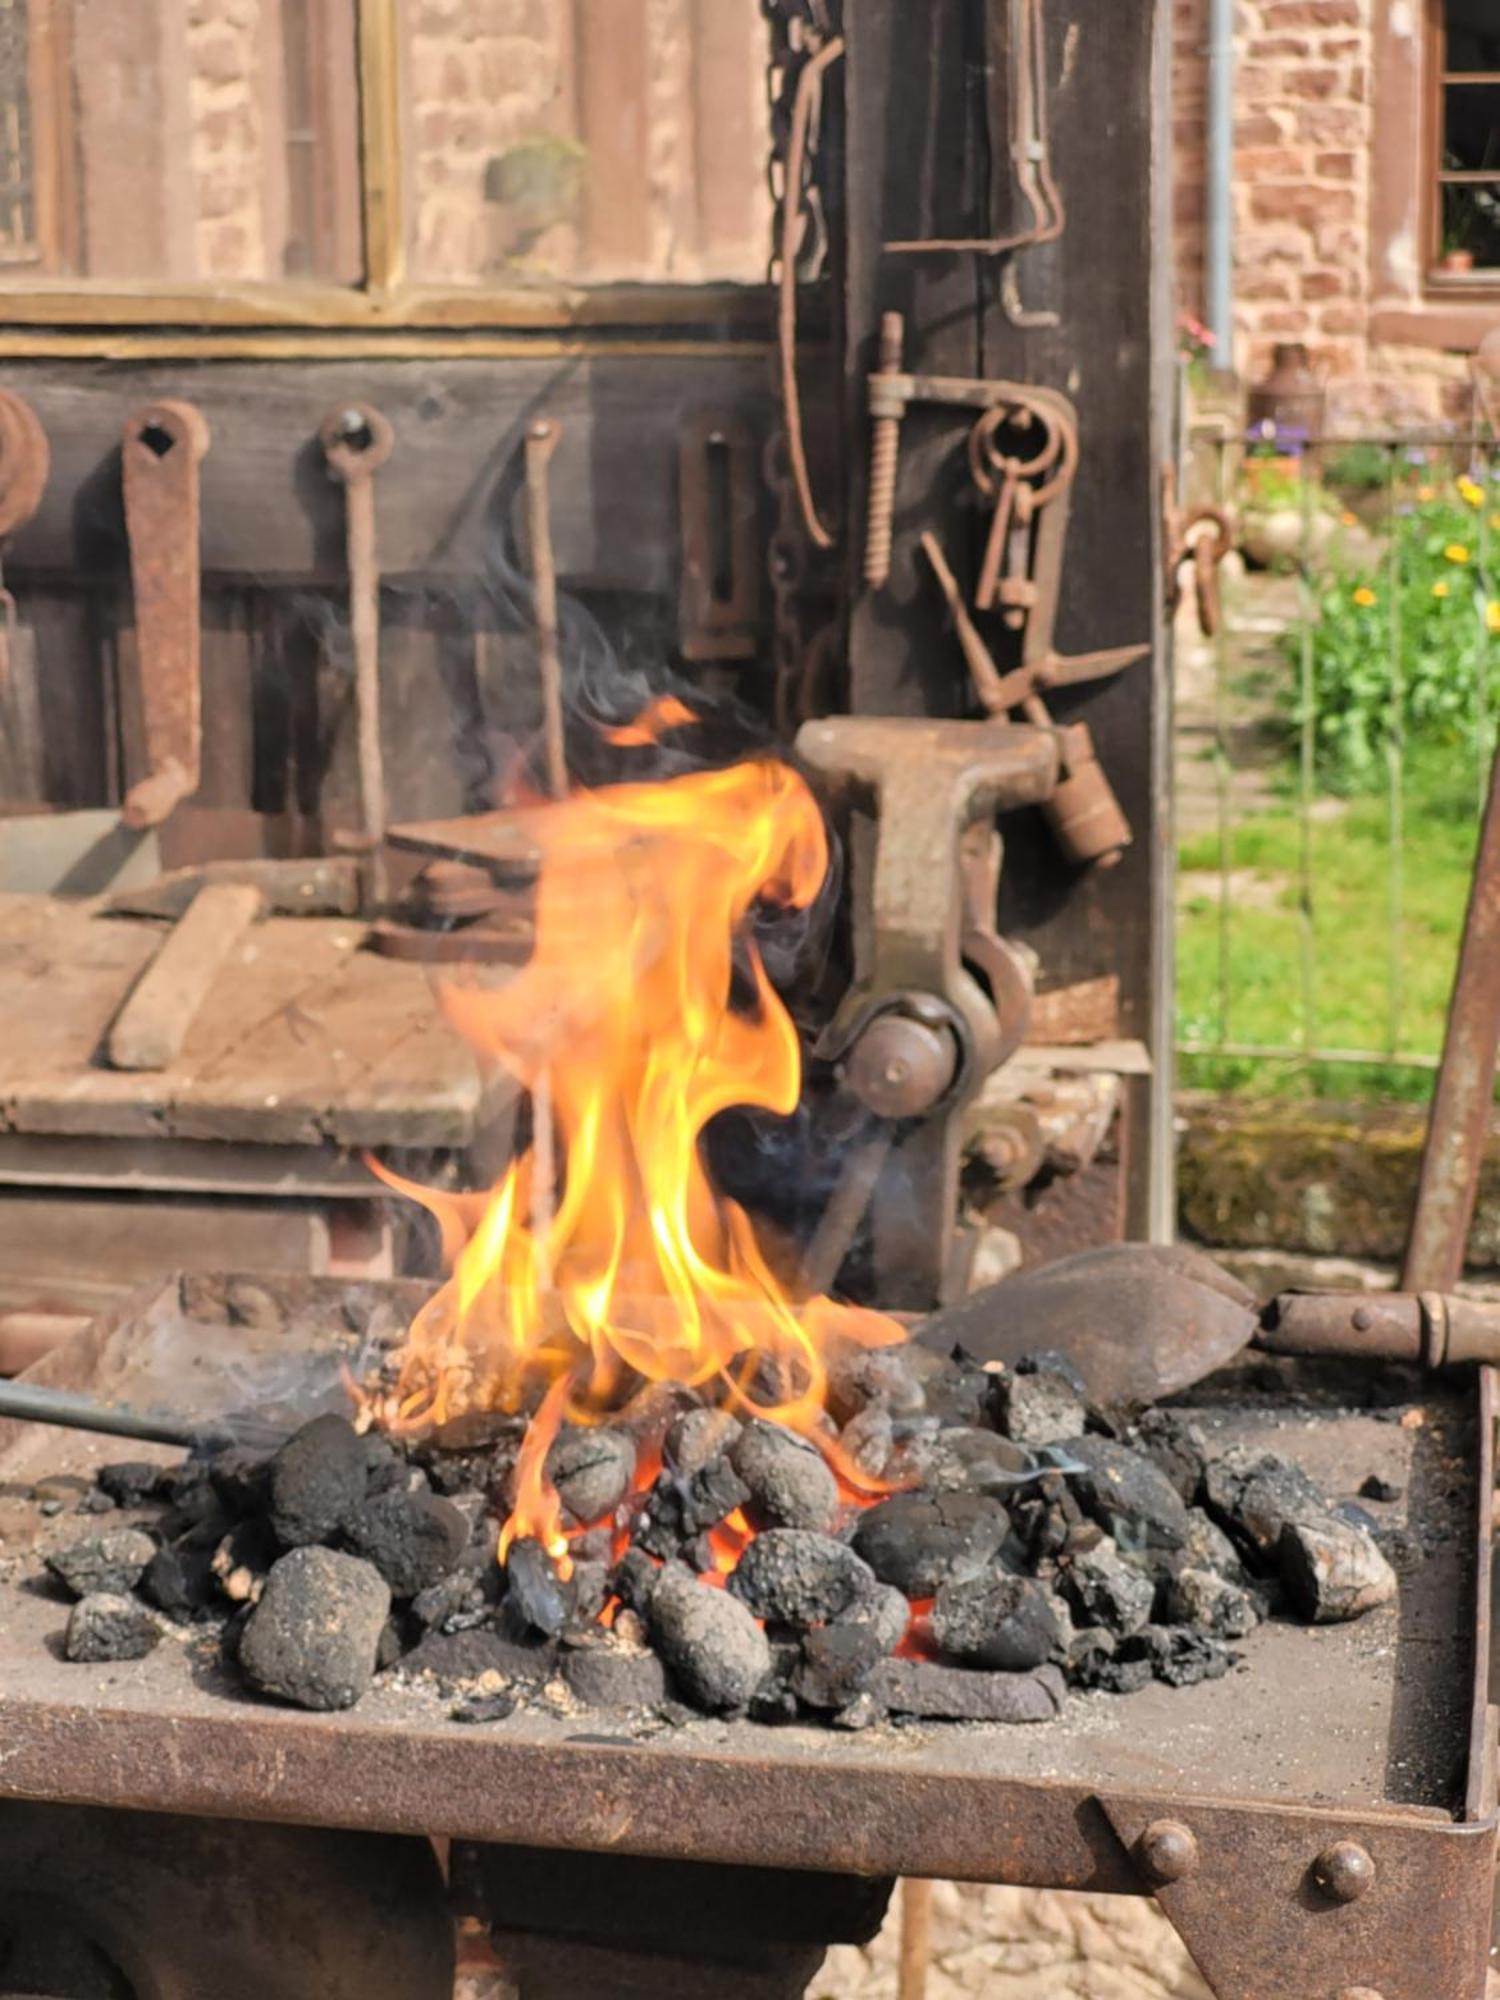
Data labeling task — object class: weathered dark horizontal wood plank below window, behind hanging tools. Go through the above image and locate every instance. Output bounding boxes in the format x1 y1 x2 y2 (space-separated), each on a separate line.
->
6 350 770 594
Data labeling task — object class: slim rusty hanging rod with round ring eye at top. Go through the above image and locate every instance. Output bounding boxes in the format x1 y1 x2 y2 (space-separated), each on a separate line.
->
318 402 396 904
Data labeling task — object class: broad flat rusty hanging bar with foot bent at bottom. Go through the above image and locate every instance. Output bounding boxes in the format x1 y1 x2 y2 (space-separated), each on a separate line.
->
120 398 208 830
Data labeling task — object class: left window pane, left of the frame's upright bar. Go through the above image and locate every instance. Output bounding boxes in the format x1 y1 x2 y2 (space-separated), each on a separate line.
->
0 0 360 284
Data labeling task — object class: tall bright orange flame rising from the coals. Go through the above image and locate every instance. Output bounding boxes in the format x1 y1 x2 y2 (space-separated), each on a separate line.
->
366 760 902 1566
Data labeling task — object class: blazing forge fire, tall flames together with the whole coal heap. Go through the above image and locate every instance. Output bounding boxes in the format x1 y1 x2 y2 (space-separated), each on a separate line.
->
26 744 1396 1728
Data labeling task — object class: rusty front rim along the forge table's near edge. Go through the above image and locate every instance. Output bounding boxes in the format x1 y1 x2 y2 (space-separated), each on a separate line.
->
4 1700 1494 1894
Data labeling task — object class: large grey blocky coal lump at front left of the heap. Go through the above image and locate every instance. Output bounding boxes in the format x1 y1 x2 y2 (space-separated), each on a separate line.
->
238 1548 390 1708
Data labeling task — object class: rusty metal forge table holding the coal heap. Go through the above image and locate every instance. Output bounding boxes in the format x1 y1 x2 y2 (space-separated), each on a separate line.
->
0 1280 1500 2000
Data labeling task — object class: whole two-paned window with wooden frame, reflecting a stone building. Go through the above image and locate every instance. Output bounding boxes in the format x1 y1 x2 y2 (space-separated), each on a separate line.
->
0 0 772 340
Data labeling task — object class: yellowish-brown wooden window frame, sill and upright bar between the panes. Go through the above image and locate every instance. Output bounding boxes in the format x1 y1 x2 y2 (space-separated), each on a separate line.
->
0 0 774 358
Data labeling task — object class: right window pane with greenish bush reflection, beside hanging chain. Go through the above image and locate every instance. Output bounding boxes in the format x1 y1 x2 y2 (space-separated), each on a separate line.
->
406 0 770 286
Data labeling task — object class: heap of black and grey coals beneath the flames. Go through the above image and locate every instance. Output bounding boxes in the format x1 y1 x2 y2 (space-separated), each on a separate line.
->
2 1286 1404 1732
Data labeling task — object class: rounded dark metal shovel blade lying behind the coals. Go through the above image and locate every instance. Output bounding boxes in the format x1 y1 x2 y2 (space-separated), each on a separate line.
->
916 1244 1258 1404
